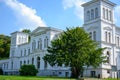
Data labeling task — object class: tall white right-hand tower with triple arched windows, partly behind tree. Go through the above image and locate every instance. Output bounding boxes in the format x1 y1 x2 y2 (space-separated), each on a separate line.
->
82 0 117 78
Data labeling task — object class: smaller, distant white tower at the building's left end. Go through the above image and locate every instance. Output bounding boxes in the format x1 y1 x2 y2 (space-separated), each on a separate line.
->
9 32 29 71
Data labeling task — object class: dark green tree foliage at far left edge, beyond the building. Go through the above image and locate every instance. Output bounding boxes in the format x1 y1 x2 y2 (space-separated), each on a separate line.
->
0 34 10 59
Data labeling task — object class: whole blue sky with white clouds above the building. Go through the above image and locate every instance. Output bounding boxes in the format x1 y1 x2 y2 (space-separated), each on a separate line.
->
0 0 120 35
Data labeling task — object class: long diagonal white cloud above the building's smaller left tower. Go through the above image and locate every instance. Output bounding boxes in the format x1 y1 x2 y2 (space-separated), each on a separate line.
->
4 0 46 30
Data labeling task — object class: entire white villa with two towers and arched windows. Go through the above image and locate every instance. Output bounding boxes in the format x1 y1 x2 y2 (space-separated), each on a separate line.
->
0 0 120 78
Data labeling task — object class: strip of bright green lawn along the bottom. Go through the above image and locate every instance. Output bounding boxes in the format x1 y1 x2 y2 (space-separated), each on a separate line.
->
0 75 120 80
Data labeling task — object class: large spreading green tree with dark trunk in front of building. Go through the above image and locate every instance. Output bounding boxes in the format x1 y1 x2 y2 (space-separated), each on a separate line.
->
43 27 105 78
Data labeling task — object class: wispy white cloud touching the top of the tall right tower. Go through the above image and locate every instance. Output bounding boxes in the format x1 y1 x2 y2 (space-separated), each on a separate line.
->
63 0 89 20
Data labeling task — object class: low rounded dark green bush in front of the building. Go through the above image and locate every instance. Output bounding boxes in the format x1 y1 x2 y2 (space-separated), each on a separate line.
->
19 65 38 76
